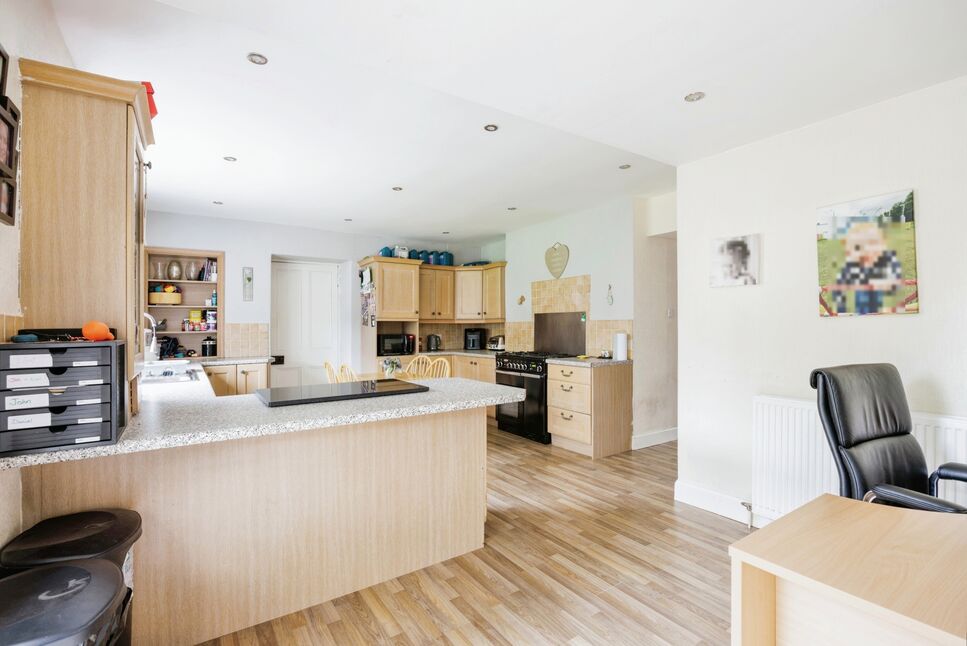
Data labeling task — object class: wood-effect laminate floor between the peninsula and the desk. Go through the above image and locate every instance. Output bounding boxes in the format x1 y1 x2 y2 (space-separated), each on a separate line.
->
207 428 745 646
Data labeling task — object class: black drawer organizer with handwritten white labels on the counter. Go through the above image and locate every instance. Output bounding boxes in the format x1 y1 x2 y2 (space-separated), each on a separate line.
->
0 341 127 456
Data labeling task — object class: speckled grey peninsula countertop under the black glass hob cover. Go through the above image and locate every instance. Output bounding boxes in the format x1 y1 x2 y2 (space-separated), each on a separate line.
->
0 359 524 470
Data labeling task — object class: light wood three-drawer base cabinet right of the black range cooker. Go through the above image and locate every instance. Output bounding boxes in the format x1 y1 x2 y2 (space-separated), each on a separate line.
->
547 363 632 458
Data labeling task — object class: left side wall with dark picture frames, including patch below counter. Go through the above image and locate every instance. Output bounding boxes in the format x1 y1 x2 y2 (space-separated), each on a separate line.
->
0 0 72 544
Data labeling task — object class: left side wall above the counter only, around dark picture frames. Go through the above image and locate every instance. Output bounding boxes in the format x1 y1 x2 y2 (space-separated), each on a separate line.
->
0 0 72 314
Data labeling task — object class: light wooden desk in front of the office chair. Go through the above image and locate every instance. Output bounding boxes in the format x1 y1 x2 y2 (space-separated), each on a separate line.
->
729 494 967 646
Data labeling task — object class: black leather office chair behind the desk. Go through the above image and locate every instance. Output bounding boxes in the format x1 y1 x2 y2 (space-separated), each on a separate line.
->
809 363 967 513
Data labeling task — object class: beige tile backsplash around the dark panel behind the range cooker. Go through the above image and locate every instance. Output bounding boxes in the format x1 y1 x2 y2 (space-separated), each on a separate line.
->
505 275 633 358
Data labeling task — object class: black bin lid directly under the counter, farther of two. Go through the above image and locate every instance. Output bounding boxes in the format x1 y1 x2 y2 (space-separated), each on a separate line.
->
0 509 141 568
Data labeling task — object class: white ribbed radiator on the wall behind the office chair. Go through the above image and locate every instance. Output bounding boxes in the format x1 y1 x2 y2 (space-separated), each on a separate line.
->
752 396 967 527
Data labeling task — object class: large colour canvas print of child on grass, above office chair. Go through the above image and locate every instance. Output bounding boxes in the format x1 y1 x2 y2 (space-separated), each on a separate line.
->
816 190 920 316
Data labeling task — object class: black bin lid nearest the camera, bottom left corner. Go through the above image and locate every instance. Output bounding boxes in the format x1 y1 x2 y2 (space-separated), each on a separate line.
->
0 559 127 646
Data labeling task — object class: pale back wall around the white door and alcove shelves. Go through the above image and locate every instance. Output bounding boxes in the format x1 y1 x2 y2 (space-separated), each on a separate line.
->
146 211 480 367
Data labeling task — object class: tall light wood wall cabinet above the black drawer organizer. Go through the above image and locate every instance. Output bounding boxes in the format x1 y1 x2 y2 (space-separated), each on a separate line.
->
20 59 154 411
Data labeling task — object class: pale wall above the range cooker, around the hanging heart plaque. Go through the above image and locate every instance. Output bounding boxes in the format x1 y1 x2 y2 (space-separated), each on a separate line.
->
505 198 637 322
